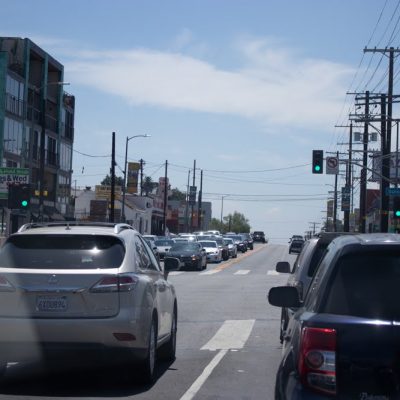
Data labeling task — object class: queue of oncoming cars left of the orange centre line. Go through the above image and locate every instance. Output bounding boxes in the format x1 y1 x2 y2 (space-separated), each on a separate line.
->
143 231 265 271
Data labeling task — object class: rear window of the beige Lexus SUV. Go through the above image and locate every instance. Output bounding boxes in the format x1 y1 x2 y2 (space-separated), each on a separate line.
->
0 235 125 269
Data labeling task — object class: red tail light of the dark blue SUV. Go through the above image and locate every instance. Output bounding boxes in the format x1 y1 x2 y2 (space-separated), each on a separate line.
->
298 327 336 395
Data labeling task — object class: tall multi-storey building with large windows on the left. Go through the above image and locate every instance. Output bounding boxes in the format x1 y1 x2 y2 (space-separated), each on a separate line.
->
0 37 75 230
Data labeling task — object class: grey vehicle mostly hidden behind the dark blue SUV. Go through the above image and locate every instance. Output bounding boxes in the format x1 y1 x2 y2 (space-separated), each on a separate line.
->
276 232 348 343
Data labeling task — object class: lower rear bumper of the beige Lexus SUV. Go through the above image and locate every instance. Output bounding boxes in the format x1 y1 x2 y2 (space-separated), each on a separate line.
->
0 312 150 361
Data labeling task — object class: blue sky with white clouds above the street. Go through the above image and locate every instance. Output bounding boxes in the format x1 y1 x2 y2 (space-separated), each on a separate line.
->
0 0 400 243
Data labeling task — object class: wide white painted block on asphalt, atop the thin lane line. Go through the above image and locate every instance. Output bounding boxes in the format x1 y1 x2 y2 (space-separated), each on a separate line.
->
201 319 255 350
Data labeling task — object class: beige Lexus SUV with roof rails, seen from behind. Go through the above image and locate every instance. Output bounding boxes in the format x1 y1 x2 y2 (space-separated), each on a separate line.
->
0 221 179 382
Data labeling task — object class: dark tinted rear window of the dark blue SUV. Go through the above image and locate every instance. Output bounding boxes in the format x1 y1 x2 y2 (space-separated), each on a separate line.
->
323 251 400 321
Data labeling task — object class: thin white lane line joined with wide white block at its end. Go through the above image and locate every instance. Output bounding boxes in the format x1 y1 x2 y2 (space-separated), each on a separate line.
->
179 319 255 400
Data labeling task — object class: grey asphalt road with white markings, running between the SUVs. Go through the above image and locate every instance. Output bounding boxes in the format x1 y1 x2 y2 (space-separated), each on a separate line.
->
0 244 295 400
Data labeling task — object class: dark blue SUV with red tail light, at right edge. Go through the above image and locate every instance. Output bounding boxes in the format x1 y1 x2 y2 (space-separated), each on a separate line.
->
268 234 400 399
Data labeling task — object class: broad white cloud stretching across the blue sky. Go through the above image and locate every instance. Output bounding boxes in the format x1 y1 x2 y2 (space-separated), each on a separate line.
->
66 37 353 129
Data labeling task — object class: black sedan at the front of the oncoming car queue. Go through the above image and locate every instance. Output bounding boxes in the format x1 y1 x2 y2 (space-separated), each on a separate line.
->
168 241 207 271
